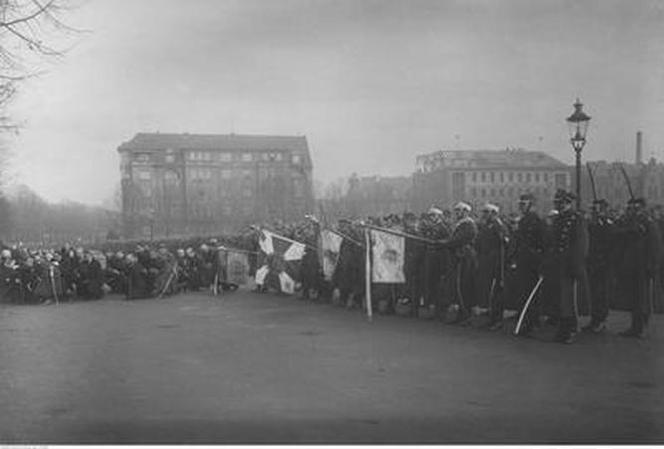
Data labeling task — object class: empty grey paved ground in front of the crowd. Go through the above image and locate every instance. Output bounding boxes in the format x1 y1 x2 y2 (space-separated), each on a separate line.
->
0 291 664 444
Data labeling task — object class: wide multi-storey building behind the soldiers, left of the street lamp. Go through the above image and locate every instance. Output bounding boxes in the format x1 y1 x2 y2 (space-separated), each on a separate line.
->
412 149 571 213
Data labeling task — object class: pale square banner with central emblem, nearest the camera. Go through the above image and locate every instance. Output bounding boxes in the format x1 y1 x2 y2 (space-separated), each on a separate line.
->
370 229 406 284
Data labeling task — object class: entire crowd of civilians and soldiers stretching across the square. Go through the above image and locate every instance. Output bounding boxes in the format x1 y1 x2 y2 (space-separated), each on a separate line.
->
0 190 664 343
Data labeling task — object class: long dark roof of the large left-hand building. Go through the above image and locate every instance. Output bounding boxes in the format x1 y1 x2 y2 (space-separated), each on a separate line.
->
118 133 308 152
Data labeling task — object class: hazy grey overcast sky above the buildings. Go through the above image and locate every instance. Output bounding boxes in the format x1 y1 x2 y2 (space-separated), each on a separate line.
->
5 0 664 203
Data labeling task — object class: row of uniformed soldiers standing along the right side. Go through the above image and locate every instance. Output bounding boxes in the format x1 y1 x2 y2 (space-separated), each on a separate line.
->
303 190 664 343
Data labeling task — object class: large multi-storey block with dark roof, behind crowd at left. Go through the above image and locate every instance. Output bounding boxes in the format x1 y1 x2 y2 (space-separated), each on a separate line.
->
118 133 313 237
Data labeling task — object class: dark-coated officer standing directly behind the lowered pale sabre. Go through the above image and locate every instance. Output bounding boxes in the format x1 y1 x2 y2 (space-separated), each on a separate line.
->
514 193 544 336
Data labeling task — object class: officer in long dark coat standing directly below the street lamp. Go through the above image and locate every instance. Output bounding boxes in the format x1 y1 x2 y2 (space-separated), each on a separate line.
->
549 189 588 344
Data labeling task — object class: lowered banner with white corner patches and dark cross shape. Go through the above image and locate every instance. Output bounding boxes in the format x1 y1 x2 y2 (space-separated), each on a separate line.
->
256 230 306 294
